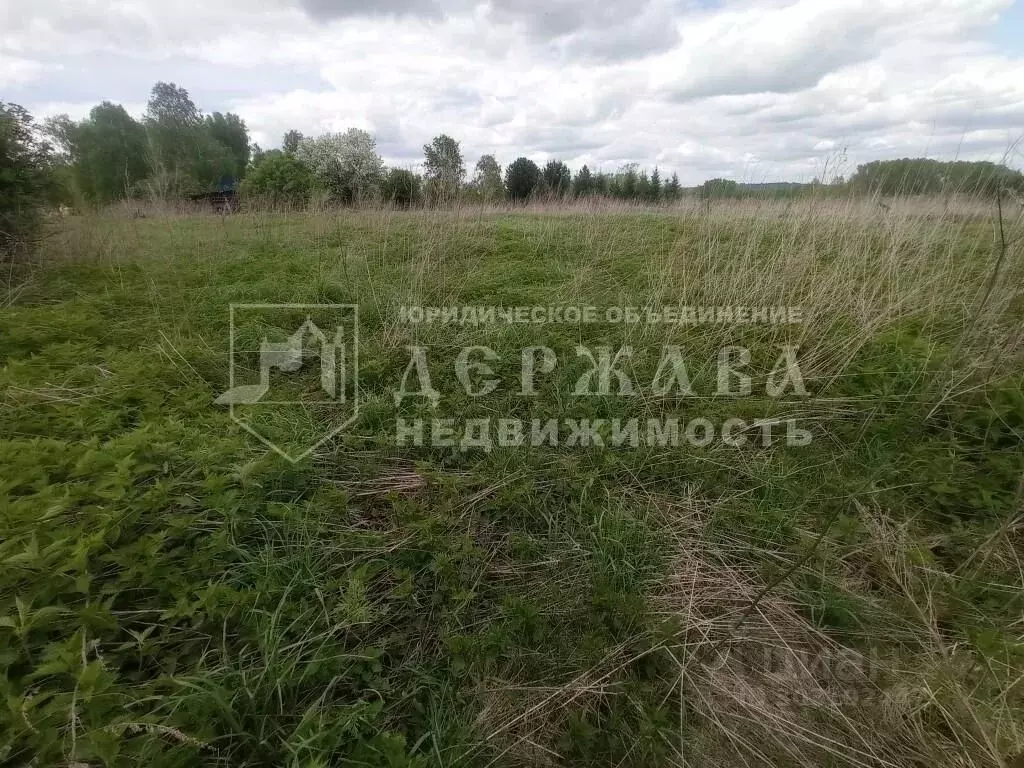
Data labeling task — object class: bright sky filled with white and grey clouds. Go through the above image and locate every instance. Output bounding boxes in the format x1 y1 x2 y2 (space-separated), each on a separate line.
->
0 0 1024 183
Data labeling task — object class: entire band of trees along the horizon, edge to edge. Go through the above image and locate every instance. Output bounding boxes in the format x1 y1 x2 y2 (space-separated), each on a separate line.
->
0 82 1024 259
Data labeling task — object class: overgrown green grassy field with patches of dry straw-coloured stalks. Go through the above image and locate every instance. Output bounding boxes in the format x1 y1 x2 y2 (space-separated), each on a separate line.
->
0 201 1024 768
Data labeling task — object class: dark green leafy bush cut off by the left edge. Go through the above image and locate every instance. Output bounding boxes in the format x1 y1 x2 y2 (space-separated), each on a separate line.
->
0 101 49 261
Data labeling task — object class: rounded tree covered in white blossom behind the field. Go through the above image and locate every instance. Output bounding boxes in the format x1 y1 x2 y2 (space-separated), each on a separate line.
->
295 128 384 203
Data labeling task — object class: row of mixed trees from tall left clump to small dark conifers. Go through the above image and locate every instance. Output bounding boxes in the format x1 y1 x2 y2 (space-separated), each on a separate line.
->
11 82 682 206
